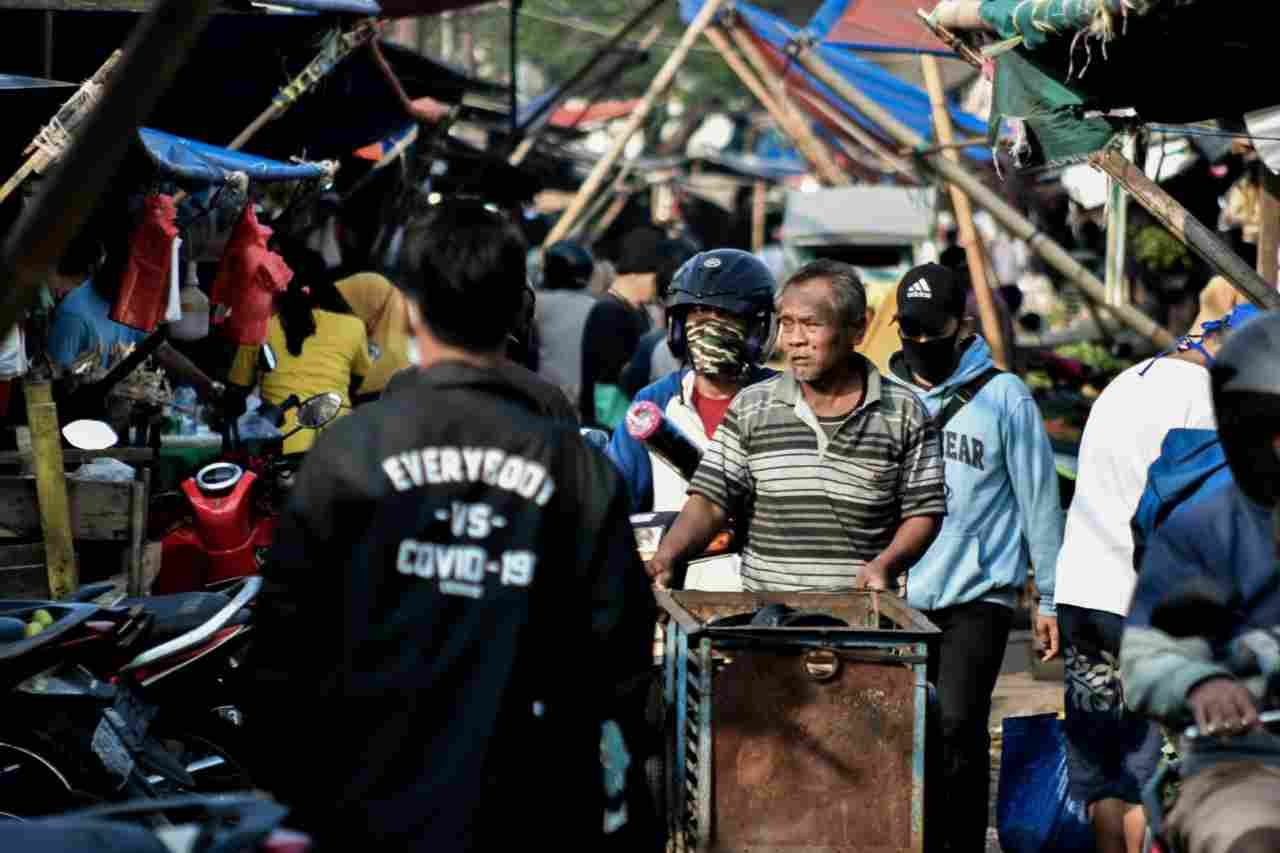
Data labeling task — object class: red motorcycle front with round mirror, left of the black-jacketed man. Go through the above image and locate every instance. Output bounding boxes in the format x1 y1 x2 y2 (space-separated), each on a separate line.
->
151 392 342 594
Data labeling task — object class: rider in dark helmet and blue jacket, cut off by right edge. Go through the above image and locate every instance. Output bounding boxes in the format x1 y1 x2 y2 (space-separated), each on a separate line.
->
1120 314 1280 853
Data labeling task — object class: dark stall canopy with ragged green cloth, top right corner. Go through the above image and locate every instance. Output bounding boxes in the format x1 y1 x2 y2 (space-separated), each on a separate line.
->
962 0 1275 165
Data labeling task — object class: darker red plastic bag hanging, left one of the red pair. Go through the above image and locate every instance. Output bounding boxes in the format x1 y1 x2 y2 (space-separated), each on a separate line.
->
111 195 178 332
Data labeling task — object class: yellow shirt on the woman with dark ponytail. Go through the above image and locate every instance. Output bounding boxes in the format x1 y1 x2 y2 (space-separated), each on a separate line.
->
227 310 372 453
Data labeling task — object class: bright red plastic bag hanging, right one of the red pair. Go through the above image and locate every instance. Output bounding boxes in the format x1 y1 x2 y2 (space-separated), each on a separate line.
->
210 204 293 346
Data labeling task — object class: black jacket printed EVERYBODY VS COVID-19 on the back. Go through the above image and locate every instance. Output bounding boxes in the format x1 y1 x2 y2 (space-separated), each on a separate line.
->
247 364 655 852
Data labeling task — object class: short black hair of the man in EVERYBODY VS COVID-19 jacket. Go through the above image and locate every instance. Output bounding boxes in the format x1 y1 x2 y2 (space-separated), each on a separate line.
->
399 200 527 351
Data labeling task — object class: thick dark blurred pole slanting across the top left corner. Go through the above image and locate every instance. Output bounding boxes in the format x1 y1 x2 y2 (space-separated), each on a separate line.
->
0 0 219 337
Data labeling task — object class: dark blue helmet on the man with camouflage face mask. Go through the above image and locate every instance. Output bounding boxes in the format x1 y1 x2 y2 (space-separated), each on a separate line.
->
667 248 778 364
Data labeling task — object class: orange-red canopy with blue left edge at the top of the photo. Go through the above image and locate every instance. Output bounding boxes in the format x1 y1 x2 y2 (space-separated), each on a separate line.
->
809 0 952 56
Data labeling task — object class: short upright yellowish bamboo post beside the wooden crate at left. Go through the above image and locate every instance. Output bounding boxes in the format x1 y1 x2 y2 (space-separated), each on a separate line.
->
23 380 79 598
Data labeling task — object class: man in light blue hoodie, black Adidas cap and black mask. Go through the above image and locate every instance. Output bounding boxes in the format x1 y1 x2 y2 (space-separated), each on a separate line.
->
890 264 1062 850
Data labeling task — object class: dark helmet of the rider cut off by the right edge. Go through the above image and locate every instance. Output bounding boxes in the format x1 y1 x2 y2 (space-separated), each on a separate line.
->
1210 313 1280 507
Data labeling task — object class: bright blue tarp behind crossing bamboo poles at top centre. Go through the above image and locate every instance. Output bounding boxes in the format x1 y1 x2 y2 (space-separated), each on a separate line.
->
680 0 991 160
